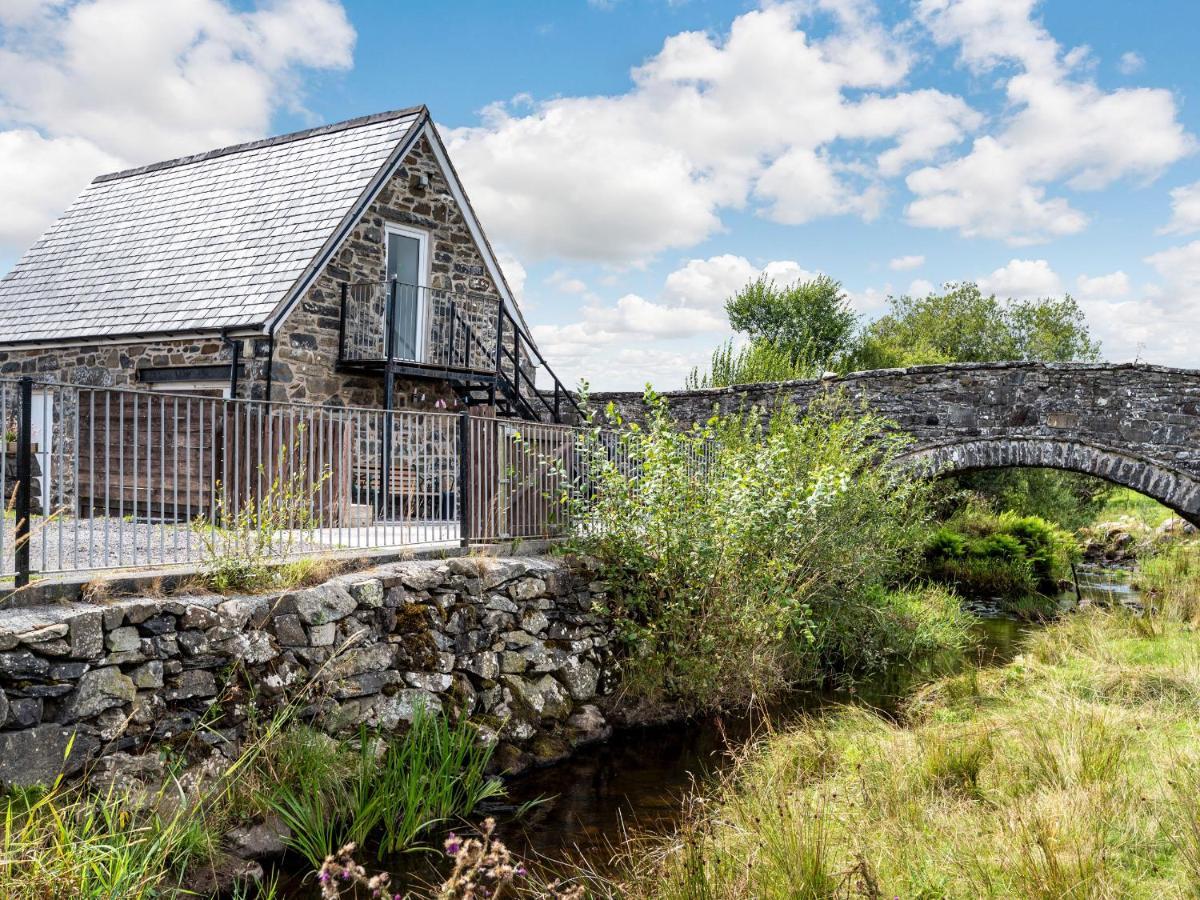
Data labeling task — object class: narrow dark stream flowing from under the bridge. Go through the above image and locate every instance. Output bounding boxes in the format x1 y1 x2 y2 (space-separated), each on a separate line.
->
270 564 1139 898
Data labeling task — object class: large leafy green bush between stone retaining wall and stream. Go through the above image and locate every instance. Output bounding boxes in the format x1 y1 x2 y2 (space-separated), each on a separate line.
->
565 395 964 709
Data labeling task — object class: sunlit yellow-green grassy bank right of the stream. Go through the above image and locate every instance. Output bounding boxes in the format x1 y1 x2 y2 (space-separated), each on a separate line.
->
618 546 1200 900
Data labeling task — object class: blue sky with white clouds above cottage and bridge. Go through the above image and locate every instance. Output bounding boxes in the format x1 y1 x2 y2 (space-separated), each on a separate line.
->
0 0 1200 388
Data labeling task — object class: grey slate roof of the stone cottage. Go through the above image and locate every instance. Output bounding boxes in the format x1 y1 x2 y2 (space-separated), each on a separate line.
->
0 107 425 343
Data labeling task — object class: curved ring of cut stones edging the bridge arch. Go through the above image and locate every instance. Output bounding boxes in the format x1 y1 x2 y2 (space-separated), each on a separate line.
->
896 437 1200 523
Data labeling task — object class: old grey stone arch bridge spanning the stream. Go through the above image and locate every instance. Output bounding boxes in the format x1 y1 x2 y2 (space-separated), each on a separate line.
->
592 362 1200 523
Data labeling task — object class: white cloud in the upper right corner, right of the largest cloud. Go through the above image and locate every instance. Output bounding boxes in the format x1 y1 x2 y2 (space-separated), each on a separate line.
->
906 0 1195 244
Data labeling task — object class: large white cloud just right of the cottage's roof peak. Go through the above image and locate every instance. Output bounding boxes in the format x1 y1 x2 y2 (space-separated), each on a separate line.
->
446 1 980 265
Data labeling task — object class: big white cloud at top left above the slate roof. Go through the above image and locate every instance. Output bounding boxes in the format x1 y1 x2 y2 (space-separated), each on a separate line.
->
0 0 354 251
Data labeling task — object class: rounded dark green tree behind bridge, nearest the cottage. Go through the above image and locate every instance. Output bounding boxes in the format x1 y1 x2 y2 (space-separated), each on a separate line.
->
725 275 858 367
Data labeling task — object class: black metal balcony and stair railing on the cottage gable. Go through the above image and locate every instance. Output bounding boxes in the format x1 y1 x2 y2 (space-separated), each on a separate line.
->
338 281 583 422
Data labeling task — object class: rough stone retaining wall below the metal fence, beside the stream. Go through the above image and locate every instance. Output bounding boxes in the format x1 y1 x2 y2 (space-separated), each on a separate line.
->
0 557 612 785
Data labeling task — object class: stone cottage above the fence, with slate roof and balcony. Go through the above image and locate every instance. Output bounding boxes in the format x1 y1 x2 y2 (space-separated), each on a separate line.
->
0 107 571 420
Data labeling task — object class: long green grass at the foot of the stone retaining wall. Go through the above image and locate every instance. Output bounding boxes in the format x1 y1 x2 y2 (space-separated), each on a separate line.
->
0 672 502 900
